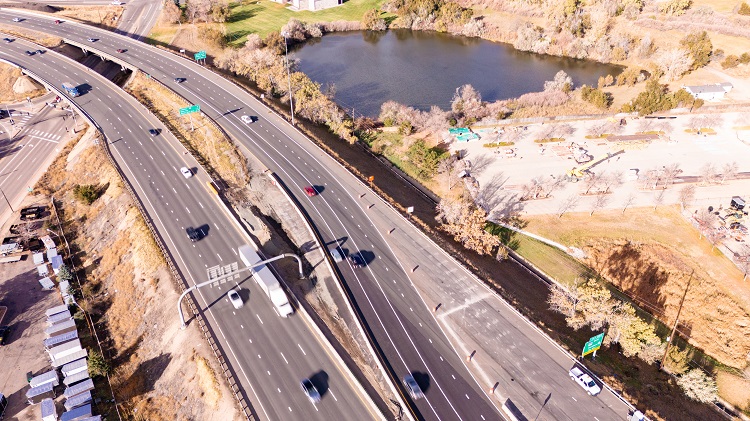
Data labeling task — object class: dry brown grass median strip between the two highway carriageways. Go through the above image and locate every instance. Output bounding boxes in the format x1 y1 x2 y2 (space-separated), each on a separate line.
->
127 74 249 186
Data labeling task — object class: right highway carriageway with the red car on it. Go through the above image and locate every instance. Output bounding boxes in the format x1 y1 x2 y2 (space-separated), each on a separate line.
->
0 11 500 420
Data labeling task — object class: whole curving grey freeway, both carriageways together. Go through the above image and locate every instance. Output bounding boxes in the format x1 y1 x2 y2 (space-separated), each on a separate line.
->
0 10 636 420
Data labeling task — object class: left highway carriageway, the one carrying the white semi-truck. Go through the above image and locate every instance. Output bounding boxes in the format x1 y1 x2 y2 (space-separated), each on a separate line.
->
0 34 380 420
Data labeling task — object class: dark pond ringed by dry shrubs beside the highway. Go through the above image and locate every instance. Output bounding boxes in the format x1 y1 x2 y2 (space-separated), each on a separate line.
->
292 29 621 117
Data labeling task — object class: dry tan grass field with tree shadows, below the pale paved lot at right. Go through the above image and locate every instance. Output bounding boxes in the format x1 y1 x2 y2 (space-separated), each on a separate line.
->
527 207 750 368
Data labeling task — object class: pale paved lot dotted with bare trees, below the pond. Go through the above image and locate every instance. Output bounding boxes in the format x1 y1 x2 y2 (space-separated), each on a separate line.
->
450 113 750 214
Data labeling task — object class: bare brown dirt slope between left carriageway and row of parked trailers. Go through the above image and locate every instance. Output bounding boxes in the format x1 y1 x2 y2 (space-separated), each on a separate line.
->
27 126 240 420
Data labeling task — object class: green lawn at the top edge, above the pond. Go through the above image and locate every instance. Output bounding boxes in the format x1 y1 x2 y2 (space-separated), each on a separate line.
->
227 0 383 45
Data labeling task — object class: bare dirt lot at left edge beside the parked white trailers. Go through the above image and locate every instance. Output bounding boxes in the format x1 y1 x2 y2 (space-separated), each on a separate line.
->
0 197 67 421
